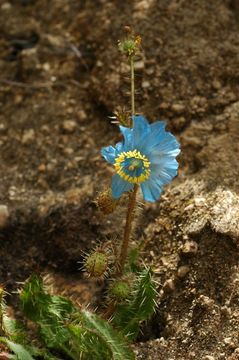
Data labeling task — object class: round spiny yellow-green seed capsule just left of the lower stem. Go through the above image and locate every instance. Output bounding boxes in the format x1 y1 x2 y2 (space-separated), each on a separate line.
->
85 251 108 277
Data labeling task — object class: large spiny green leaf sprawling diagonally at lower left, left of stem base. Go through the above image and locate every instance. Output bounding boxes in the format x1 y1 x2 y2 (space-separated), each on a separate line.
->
20 276 134 360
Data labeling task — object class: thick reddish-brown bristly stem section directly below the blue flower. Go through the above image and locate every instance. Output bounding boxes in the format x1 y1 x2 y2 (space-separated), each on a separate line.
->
116 184 139 276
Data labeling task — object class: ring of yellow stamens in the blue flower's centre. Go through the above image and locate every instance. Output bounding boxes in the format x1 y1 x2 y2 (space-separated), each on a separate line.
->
114 150 150 184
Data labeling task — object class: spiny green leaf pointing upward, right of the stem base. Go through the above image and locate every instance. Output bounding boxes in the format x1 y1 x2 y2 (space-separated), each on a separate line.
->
113 269 157 340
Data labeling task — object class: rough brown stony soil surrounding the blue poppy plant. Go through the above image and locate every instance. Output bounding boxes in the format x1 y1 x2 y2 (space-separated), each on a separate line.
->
0 0 239 360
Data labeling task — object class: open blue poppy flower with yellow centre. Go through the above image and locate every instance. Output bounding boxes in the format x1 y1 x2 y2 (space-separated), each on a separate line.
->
101 116 180 202
